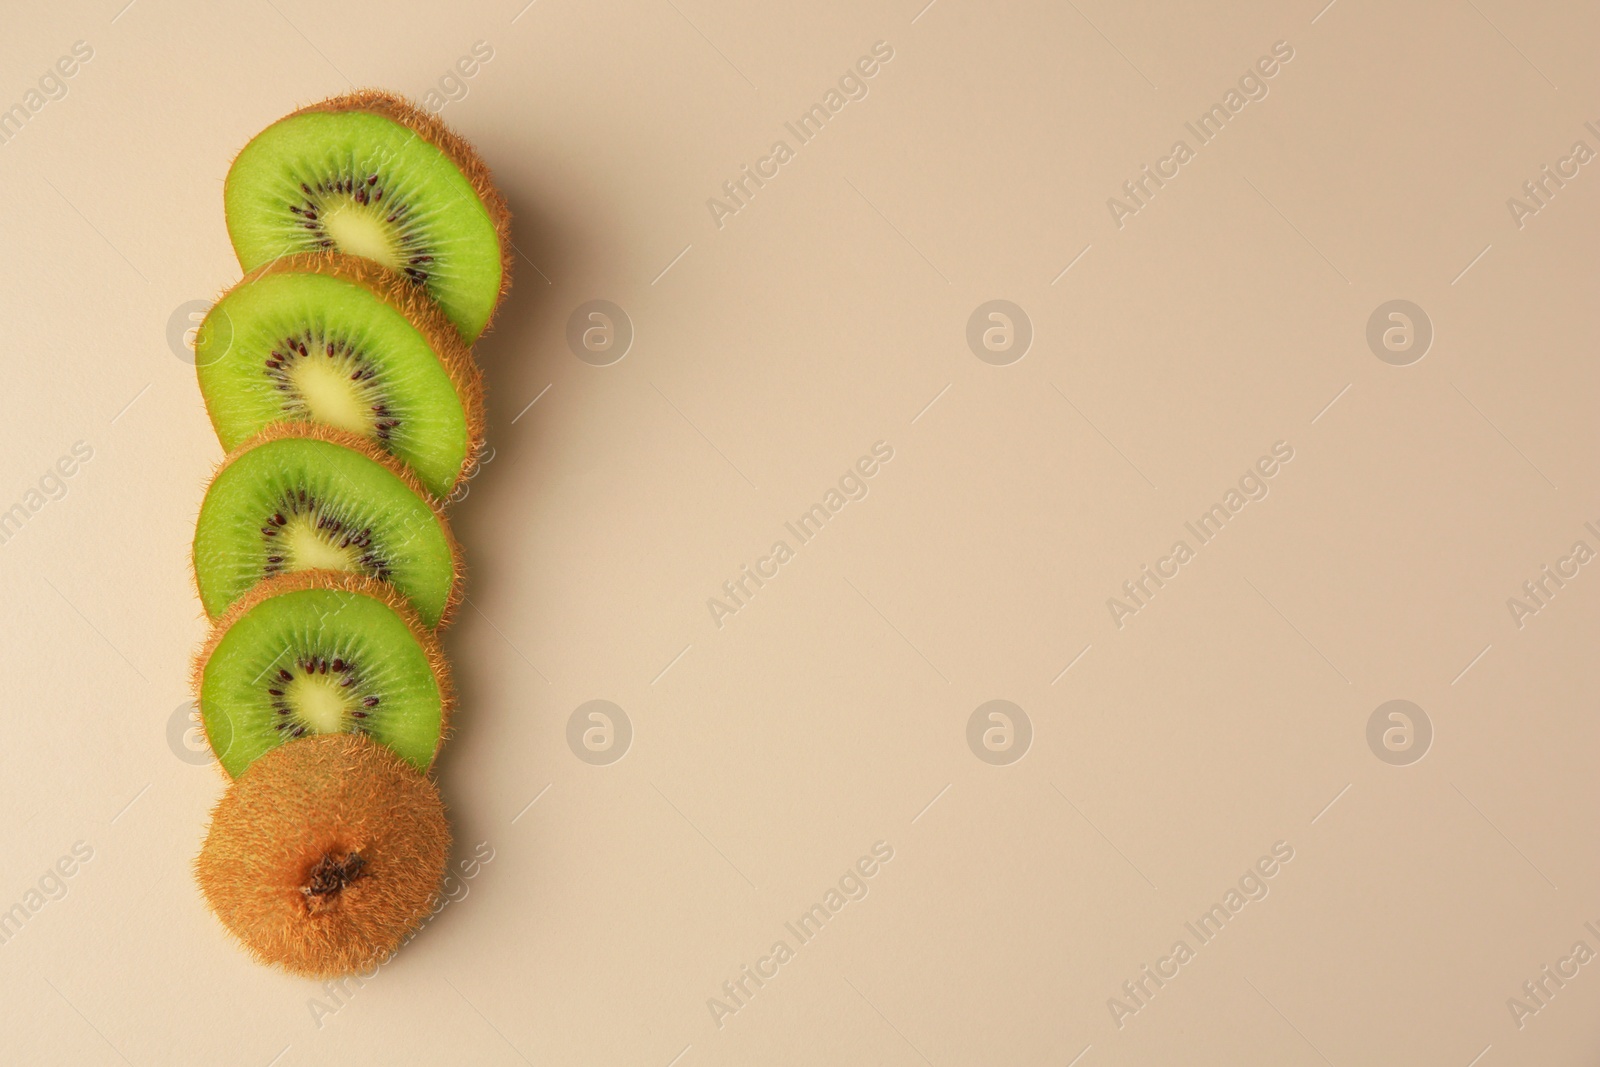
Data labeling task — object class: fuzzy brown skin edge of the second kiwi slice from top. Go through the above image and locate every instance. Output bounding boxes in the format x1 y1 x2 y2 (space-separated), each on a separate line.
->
197 251 485 486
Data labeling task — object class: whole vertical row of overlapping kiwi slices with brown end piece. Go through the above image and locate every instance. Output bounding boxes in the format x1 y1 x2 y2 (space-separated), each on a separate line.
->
194 91 510 977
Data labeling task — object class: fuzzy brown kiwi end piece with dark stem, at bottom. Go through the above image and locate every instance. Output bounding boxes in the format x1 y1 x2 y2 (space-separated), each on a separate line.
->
195 734 450 977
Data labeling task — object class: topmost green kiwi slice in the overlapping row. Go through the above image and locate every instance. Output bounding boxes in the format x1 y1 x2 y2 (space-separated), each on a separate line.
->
222 90 510 344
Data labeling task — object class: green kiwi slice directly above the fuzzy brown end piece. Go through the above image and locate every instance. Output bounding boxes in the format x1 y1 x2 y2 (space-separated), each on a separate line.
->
194 571 454 777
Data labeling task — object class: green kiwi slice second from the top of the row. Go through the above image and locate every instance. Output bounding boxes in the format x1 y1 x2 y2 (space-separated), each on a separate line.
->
195 253 483 499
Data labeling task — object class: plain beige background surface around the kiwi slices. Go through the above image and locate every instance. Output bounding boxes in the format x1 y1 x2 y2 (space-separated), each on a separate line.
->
0 0 1600 1067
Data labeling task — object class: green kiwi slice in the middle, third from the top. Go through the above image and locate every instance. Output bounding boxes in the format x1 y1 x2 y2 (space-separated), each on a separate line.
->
194 422 462 629
